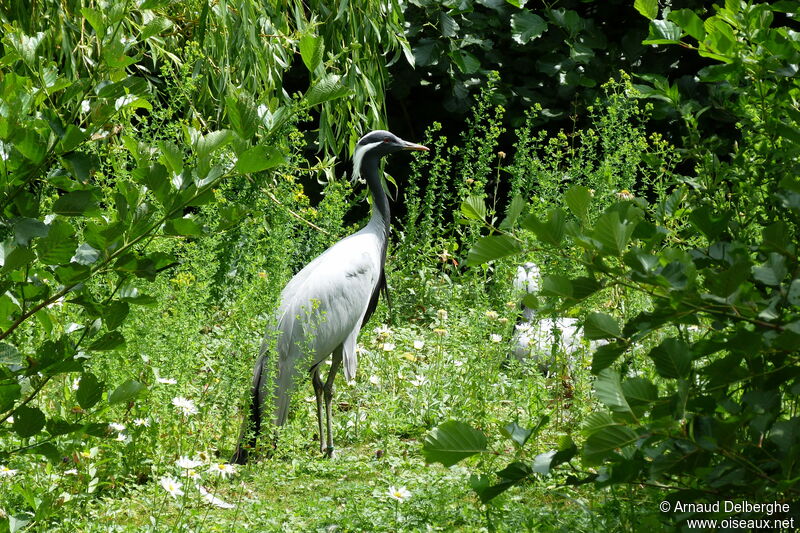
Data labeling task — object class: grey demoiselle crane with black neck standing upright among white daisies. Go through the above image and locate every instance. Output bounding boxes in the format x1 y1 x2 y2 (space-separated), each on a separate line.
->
231 130 428 464
